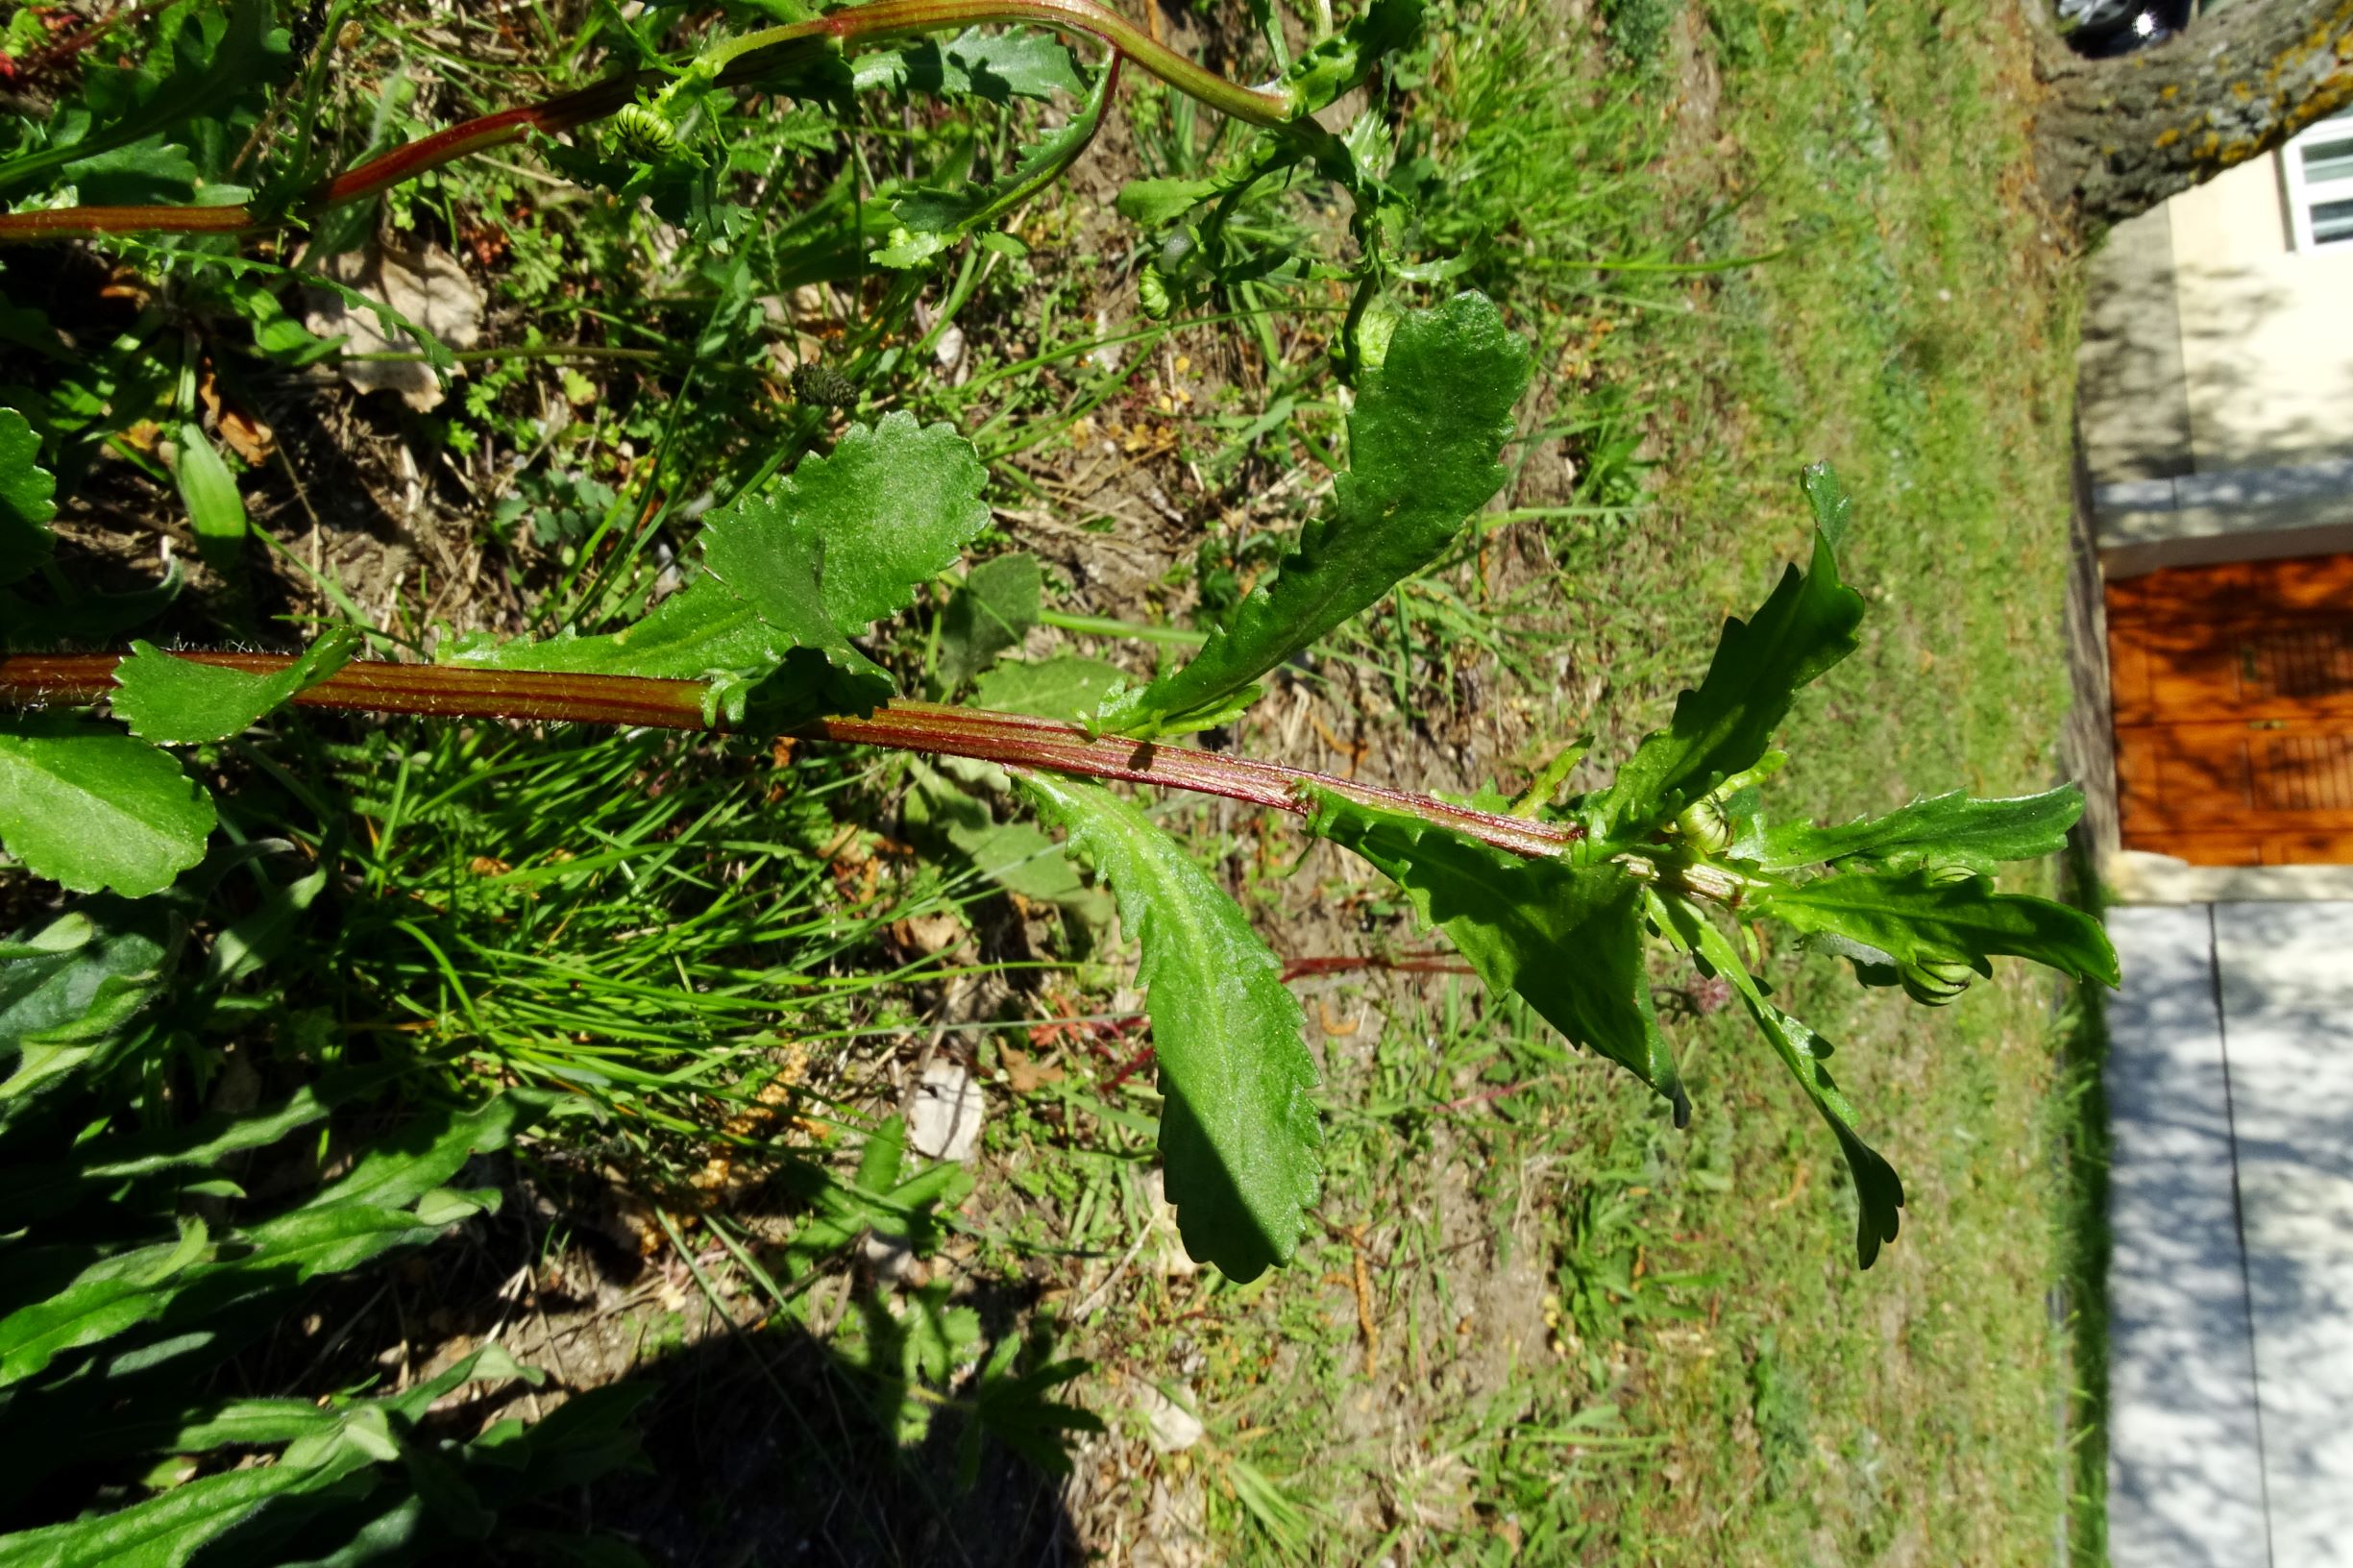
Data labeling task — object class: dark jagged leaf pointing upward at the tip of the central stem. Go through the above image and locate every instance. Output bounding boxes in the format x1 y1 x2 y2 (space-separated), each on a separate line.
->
1593 464 1864 855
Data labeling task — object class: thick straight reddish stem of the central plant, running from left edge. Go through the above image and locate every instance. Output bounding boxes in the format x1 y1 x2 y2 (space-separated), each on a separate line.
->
0 652 1581 857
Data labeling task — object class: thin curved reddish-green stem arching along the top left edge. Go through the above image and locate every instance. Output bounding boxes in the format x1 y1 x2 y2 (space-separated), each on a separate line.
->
0 0 1292 242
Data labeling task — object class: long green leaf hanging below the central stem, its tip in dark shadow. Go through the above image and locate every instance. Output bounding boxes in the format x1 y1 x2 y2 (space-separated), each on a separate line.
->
1021 774 1322 1281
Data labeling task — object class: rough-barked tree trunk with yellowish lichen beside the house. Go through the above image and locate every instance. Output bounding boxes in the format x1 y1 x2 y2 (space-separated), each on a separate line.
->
2026 0 2353 231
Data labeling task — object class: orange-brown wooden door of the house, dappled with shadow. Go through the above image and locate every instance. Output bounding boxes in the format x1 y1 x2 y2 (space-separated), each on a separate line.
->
2108 553 2353 867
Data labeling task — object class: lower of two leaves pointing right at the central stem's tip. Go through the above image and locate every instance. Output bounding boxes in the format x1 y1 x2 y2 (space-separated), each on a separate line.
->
1751 871 2118 987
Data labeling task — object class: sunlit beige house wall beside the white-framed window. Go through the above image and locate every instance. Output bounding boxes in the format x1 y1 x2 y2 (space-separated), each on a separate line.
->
2165 158 2353 474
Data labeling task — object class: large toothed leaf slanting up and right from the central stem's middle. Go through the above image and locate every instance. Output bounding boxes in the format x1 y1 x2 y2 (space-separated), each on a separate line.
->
1096 294 1527 737
